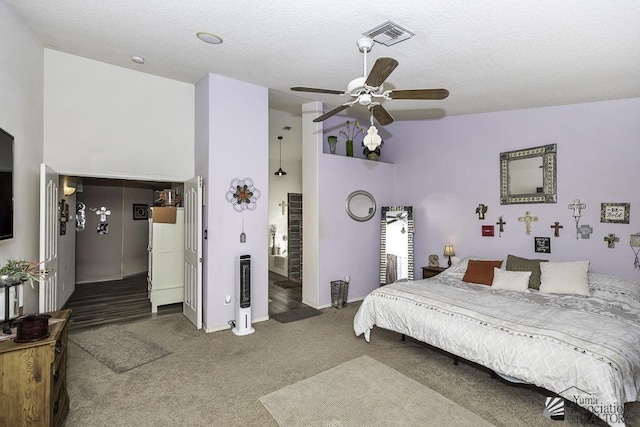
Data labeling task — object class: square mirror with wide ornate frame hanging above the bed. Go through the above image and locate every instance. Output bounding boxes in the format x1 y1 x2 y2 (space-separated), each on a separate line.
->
500 144 557 205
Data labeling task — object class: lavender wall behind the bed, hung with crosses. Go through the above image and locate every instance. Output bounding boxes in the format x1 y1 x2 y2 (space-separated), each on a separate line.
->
384 99 640 278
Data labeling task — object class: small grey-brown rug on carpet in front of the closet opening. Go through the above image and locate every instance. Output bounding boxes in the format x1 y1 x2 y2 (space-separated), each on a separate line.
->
69 325 171 374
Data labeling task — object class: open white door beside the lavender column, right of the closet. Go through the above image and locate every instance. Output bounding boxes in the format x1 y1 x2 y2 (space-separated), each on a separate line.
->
182 176 202 329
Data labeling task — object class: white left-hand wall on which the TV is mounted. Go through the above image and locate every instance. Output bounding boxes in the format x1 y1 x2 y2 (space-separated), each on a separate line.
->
0 0 43 313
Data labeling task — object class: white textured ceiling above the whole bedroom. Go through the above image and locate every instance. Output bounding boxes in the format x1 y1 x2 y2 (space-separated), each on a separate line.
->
5 0 640 120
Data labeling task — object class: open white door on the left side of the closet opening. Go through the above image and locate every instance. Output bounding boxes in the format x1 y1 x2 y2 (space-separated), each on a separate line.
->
38 163 59 313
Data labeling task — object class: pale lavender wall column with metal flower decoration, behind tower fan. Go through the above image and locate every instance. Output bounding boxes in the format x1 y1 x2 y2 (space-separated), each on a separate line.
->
196 74 269 331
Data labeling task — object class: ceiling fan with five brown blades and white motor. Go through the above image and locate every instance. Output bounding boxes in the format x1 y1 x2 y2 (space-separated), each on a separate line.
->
291 37 449 126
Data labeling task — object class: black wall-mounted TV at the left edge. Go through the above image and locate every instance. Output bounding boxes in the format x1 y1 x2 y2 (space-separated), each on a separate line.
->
0 128 13 240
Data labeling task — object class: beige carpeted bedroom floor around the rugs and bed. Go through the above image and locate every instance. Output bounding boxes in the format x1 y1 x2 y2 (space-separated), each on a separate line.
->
66 303 640 427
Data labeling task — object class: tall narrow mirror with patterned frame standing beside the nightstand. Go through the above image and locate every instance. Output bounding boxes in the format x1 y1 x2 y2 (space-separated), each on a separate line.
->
380 206 413 285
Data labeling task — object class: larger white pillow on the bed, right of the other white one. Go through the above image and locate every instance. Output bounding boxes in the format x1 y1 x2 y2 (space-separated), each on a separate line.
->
540 261 591 297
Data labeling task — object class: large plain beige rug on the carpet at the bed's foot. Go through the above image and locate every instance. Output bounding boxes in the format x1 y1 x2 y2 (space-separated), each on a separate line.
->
260 356 495 427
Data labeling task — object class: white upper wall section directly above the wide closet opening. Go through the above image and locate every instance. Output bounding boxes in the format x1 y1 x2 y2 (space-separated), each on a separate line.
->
44 49 194 181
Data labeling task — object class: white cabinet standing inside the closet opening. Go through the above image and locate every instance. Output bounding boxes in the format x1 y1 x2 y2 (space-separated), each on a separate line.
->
147 208 184 313
